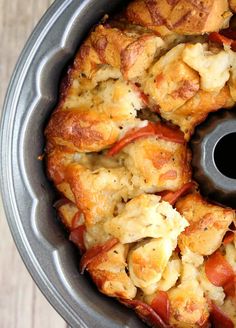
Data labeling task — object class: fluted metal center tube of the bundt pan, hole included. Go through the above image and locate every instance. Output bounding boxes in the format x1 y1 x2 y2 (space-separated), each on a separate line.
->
191 111 236 208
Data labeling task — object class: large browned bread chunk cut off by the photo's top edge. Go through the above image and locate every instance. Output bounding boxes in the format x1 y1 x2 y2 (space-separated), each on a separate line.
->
126 0 231 35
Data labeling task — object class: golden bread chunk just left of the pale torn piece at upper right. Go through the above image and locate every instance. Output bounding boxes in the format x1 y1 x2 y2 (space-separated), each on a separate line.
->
142 44 200 113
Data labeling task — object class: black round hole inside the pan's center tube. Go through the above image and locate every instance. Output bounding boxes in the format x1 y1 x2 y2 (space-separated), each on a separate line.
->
213 132 236 179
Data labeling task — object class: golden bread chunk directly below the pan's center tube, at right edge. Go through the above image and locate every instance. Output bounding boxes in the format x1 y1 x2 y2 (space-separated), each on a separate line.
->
176 193 235 255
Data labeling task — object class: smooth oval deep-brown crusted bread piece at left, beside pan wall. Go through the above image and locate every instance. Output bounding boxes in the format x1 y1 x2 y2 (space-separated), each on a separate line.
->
45 109 119 152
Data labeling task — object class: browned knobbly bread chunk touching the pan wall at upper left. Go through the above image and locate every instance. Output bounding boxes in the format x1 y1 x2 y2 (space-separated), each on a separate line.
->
76 24 164 79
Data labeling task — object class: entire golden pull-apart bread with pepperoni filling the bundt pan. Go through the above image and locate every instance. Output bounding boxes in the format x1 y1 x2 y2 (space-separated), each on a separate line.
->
45 0 236 328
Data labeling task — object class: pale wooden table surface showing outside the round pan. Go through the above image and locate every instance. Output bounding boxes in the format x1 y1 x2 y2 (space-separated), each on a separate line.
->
0 0 68 328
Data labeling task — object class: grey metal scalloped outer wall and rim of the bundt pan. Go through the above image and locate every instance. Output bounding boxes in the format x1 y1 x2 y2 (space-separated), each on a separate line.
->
1 0 144 328
